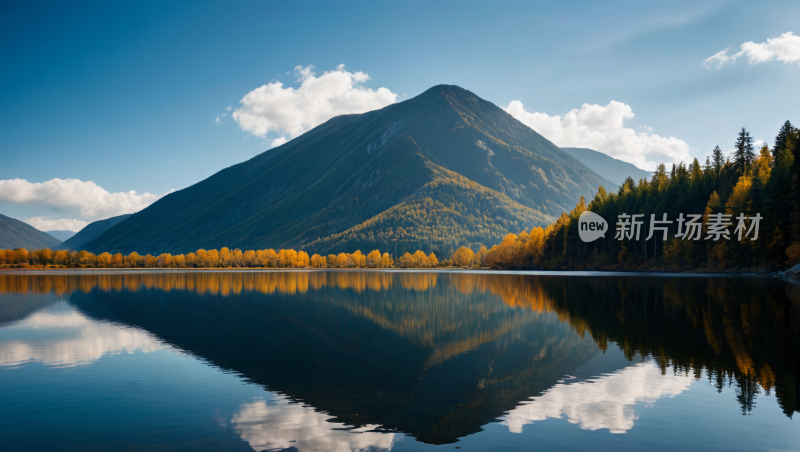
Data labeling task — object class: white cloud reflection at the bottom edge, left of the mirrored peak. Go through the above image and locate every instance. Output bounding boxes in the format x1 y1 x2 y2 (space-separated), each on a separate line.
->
231 396 402 452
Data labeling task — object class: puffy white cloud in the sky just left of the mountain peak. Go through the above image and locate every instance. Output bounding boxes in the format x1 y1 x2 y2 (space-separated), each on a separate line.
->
233 64 397 138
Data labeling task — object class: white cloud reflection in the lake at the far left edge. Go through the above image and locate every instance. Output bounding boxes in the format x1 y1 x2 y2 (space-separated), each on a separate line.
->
0 301 164 367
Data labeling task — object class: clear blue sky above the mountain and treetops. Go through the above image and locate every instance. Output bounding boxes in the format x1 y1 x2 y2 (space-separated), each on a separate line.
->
0 1 800 229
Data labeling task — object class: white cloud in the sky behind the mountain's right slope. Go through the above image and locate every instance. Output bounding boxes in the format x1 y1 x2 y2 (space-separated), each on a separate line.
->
504 100 691 170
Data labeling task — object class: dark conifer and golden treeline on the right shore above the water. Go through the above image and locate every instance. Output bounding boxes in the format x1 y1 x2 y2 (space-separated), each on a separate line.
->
482 121 800 270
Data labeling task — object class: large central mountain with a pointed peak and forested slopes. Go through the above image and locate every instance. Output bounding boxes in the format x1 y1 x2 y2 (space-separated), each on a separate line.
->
86 85 613 254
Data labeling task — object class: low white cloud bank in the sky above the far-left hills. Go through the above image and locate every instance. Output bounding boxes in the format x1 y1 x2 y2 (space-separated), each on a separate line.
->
0 178 169 219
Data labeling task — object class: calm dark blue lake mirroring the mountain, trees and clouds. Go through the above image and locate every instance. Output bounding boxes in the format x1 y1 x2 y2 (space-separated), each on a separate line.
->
0 272 800 452
